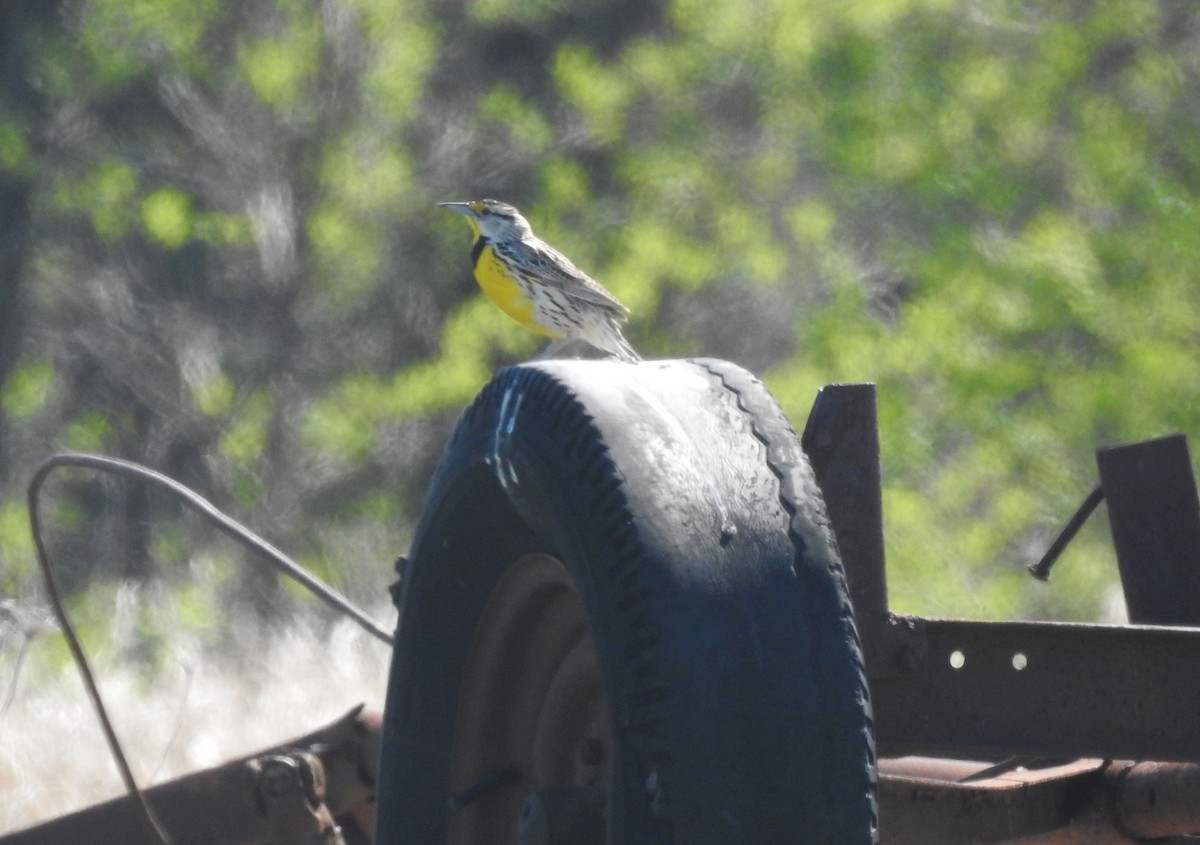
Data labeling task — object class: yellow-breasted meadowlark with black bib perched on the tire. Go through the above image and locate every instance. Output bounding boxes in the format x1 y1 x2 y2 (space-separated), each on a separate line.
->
438 199 641 362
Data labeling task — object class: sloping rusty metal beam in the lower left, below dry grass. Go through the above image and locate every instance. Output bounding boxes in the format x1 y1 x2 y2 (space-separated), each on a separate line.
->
0 707 380 845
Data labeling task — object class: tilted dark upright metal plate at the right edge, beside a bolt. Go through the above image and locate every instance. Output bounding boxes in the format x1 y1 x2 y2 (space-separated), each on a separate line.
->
1096 435 1200 625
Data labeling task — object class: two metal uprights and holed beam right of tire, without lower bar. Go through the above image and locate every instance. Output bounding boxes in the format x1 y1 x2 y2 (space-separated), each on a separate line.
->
803 384 1200 762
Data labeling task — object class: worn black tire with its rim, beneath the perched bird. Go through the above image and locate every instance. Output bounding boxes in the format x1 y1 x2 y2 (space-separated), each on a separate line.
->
377 360 877 845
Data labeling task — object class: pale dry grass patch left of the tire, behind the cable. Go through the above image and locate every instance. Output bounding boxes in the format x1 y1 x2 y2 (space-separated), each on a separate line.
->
0 609 394 832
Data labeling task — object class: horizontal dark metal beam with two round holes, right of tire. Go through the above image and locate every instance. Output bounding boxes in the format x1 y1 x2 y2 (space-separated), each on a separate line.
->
871 617 1200 762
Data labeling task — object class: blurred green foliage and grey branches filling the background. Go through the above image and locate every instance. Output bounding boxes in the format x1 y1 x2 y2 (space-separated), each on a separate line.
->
0 0 1200 667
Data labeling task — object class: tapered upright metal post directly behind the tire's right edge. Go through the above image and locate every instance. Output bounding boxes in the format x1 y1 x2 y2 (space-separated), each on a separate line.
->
800 384 893 676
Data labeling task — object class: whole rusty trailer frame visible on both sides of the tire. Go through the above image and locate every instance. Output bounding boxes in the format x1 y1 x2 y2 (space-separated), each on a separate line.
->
0 384 1200 845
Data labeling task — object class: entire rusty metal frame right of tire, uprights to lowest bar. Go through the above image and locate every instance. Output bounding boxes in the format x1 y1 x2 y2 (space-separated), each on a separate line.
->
802 384 1200 845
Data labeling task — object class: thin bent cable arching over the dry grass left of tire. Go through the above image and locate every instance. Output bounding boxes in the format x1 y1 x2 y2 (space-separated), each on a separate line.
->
28 454 394 844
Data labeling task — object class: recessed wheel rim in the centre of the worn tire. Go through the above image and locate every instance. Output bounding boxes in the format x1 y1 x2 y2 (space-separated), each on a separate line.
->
449 555 612 845
